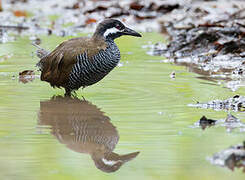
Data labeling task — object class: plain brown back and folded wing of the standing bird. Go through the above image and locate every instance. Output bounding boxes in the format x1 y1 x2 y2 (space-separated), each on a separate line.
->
40 37 107 87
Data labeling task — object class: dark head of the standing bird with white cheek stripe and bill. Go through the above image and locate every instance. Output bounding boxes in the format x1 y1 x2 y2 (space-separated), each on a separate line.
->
94 19 141 39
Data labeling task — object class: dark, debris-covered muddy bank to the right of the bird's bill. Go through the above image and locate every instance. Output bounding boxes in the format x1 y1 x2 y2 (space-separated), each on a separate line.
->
145 0 245 91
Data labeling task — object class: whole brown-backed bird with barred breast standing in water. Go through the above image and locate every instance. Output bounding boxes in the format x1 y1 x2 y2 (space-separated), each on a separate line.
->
34 19 142 96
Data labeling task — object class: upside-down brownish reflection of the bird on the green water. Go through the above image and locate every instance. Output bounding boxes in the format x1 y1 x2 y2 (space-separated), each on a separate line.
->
39 97 139 172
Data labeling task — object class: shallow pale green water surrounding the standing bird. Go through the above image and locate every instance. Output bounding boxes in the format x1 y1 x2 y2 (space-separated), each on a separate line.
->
0 34 245 180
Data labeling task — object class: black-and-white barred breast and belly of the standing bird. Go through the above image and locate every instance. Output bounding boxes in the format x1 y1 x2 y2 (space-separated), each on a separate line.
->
67 40 120 91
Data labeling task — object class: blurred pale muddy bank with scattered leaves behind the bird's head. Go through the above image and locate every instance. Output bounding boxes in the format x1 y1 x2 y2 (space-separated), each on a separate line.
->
0 0 183 43
